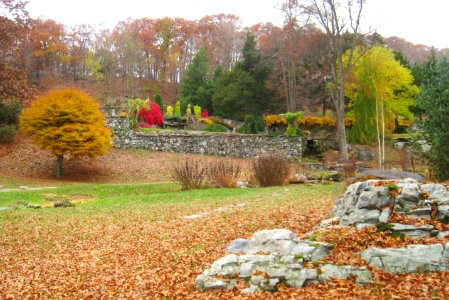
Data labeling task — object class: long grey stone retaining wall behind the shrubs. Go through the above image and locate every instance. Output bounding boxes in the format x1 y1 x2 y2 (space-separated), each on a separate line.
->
107 118 304 159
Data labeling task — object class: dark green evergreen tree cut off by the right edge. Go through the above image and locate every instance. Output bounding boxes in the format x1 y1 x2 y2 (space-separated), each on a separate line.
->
418 55 449 180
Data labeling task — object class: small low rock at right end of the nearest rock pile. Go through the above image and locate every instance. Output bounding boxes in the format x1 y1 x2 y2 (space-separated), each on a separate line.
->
319 264 373 284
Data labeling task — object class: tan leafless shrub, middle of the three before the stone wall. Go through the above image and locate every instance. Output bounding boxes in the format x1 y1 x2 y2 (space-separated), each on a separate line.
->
208 160 242 188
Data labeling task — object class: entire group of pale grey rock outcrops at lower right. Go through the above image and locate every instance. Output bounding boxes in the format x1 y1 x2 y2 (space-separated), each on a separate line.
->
195 179 449 294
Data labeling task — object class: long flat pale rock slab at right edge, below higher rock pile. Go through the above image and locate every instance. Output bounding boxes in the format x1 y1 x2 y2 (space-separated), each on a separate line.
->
361 244 448 274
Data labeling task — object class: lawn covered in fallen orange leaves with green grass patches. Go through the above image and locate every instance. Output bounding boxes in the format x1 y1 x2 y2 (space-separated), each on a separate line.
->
0 184 449 299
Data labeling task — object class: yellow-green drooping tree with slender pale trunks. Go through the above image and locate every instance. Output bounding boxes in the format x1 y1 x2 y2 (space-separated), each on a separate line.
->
343 46 418 168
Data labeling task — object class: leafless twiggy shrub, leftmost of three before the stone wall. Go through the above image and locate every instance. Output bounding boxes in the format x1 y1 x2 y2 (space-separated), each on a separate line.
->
171 160 208 191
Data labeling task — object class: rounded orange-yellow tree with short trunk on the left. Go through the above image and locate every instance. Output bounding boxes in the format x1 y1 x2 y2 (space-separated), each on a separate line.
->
20 89 111 177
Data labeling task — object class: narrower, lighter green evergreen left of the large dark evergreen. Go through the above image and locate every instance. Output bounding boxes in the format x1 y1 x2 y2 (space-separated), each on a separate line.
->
179 48 213 111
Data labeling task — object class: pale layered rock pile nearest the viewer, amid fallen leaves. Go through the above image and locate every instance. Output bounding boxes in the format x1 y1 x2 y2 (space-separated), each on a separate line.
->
195 229 372 294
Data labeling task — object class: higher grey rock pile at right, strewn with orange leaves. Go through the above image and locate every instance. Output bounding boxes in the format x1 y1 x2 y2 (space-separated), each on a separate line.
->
328 178 449 238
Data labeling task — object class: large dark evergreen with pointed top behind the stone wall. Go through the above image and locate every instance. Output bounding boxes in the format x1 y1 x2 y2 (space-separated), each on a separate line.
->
212 33 280 120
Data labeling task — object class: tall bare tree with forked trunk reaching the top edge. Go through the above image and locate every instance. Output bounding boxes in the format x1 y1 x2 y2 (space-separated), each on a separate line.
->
300 0 366 161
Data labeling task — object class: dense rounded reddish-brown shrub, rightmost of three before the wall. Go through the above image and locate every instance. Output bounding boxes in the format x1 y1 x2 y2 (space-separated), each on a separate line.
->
253 154 289 186
